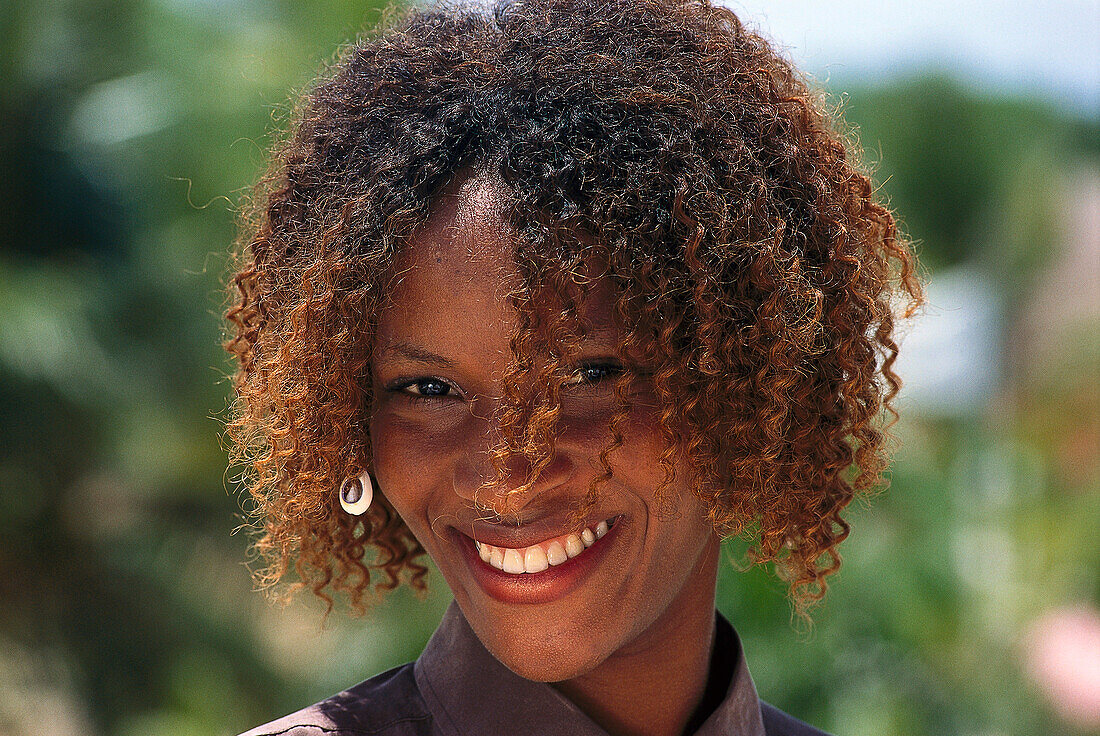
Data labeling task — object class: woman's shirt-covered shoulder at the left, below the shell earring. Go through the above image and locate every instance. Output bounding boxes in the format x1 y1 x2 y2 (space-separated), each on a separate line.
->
240 663 431 736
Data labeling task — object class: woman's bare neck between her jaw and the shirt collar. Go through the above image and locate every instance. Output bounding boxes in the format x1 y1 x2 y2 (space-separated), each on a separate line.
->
553 539 719 736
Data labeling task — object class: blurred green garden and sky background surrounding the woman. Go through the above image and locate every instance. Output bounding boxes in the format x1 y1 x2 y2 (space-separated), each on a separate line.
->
0 0 1100 736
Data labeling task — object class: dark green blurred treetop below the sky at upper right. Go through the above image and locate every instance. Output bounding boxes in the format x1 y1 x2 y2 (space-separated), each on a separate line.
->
838 74 1098 270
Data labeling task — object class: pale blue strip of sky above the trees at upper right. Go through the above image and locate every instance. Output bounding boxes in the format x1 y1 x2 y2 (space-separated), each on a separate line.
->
722 0 1100 118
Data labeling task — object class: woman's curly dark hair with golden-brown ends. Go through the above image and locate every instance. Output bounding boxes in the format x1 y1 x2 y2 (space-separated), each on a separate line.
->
226 0 922 613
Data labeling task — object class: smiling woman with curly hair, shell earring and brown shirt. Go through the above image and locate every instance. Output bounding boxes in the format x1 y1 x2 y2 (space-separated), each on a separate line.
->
228 0 920 735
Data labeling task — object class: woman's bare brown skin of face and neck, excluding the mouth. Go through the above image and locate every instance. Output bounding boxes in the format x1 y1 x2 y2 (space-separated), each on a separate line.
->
371 177 719 735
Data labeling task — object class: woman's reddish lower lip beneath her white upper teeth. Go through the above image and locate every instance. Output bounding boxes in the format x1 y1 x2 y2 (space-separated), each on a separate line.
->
454 518 623 603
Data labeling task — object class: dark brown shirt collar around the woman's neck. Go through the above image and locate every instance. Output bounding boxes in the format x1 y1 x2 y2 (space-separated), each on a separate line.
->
414 602 765 736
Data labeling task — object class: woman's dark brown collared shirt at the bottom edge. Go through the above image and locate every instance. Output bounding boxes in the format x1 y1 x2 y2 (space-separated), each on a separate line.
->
241 603 822 736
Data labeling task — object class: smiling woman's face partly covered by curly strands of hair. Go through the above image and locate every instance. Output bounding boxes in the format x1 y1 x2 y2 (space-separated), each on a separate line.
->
371 178 718 682
